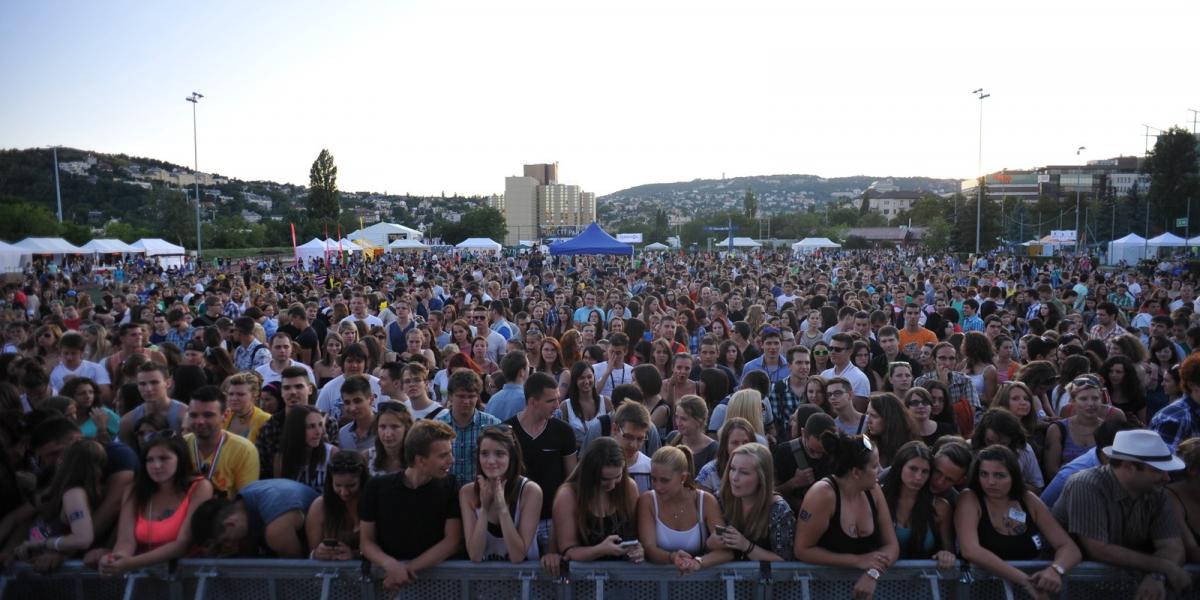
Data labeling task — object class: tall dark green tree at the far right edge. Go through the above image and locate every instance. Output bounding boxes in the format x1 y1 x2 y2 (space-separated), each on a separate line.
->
1142 127 1200 234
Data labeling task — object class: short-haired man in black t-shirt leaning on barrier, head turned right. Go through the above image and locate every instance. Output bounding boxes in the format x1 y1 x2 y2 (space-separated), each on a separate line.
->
359 419 462 590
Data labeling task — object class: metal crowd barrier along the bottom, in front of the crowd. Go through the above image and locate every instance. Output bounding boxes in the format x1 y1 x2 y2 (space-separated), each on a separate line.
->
0 559 1200 600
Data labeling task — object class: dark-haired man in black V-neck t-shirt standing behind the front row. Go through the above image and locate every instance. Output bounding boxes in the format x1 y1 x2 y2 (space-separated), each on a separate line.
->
504 372 576 548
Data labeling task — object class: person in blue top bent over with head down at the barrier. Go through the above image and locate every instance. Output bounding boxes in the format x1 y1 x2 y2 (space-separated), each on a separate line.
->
192 479 318 558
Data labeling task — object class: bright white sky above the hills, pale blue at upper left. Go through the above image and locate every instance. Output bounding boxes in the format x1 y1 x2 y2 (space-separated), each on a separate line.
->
0 0 1200 194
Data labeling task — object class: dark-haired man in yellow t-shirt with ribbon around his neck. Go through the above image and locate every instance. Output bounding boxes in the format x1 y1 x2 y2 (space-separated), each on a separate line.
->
184 385 259 498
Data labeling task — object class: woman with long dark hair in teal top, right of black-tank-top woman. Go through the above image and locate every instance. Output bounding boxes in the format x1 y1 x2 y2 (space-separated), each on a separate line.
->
882 441 955 569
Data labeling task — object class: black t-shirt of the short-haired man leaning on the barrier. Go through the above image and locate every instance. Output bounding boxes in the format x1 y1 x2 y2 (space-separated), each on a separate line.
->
359 472 462 560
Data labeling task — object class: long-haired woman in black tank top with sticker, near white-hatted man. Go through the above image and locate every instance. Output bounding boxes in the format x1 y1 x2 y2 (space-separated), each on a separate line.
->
954 445 1082 598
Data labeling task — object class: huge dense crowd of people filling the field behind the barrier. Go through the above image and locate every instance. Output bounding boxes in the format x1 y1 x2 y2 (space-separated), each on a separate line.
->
0 250 1200 599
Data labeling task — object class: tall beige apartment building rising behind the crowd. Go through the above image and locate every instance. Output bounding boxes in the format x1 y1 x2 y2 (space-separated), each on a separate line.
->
492 163 596 246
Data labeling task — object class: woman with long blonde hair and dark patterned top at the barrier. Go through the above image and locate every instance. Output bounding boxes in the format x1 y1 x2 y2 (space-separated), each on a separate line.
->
708 443 796 562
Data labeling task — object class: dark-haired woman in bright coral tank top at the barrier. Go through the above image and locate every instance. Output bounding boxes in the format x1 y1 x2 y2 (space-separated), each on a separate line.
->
97 430 212 576
